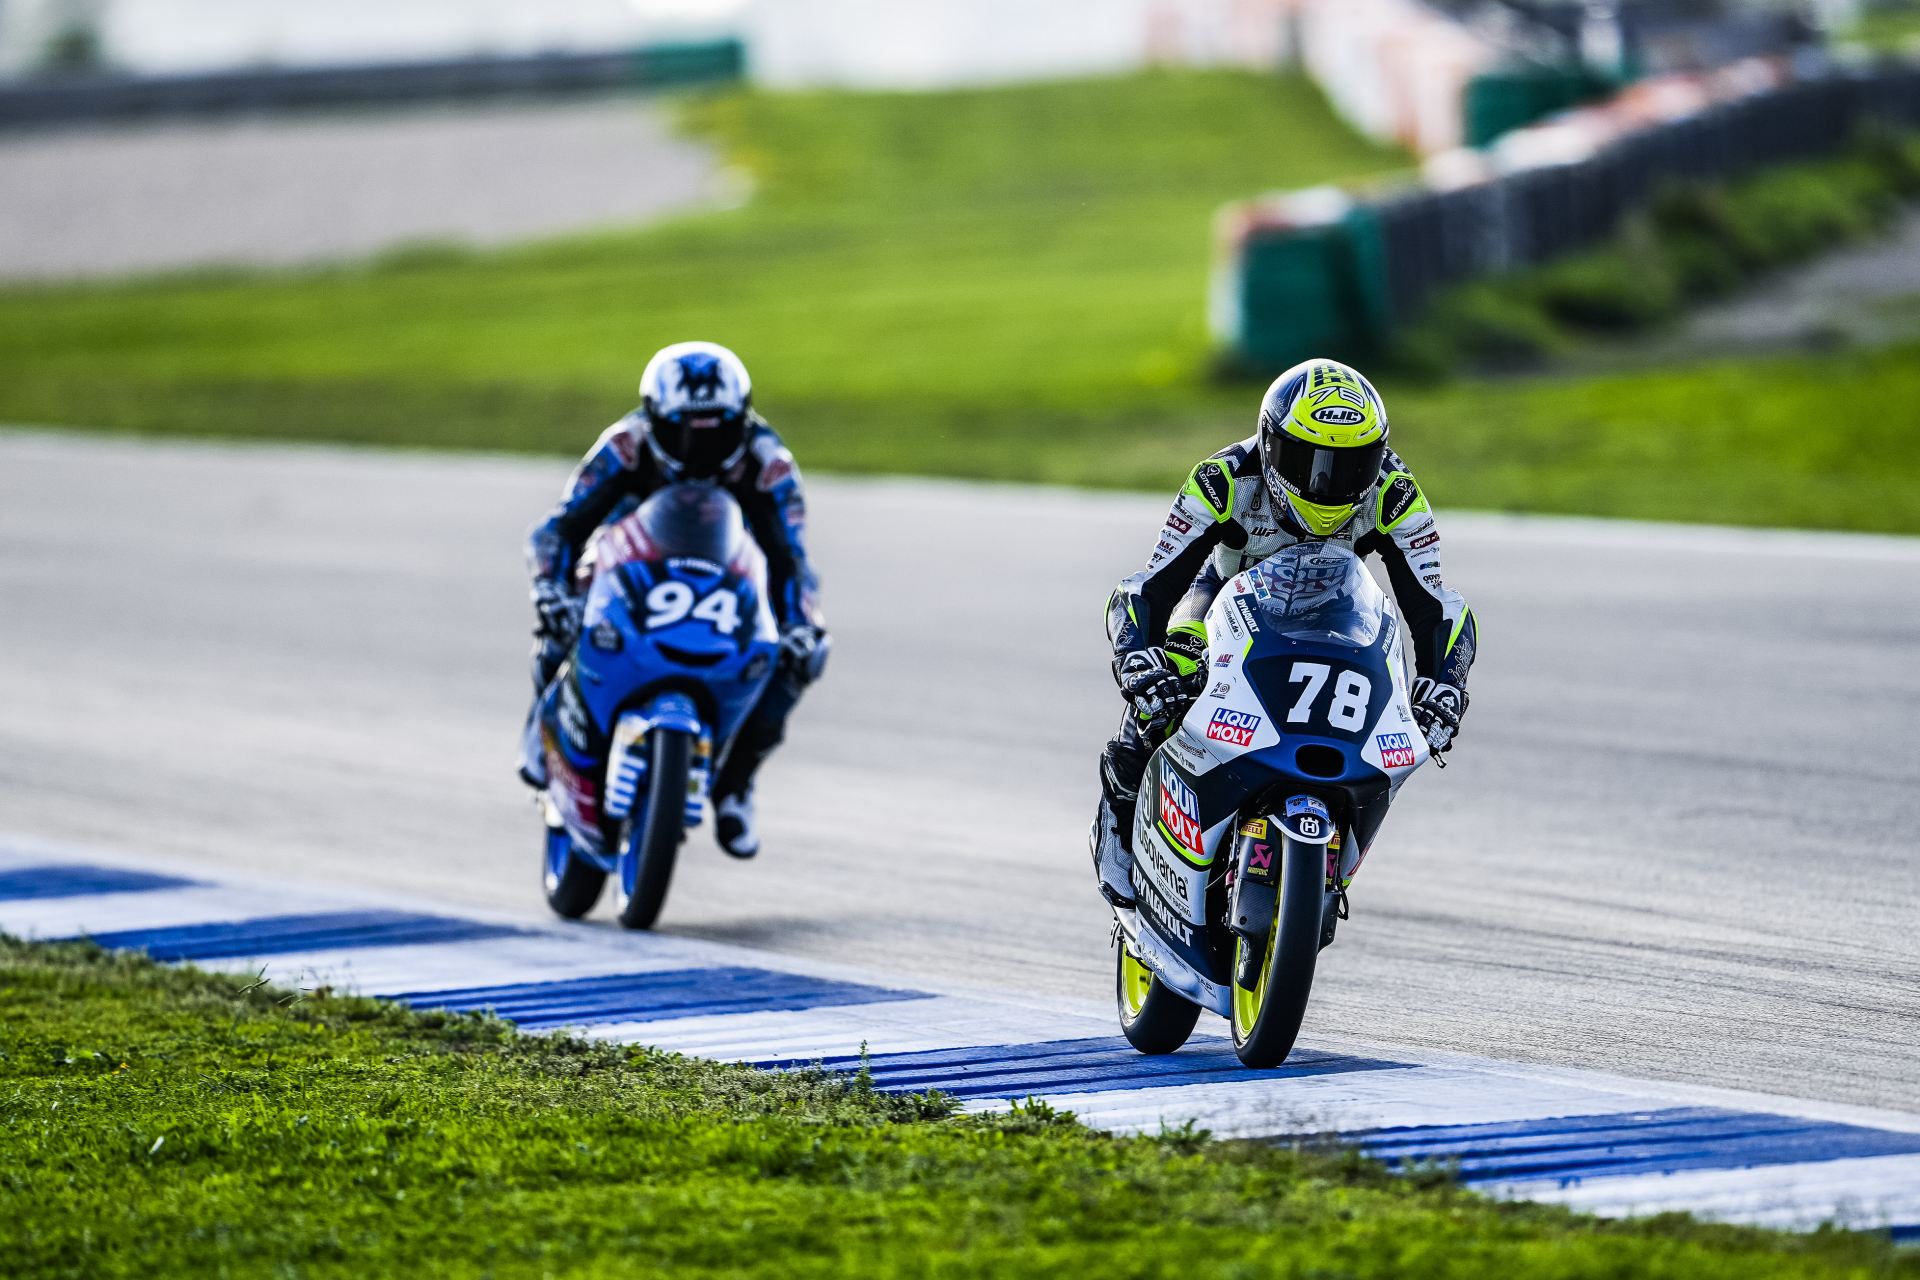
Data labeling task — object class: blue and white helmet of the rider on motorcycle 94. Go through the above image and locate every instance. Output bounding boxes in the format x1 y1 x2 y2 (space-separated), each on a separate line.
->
639 342 753 478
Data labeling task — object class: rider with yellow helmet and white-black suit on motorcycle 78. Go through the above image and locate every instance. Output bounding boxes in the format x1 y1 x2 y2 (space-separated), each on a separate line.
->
1091 359 1478 908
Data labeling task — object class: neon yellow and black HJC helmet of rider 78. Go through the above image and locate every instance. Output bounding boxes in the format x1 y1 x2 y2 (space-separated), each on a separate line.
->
1260 361 1386 537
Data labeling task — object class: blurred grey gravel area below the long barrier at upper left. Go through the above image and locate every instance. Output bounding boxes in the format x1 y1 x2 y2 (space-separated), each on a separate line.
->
0 98 722 278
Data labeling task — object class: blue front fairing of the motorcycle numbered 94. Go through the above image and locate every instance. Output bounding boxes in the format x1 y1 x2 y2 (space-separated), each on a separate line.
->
540 486 780 854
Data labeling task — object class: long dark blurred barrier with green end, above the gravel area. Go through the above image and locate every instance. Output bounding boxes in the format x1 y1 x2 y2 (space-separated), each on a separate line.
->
0 40 747 127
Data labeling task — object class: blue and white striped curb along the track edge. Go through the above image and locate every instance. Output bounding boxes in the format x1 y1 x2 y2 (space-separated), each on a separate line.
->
0 839 1920 1240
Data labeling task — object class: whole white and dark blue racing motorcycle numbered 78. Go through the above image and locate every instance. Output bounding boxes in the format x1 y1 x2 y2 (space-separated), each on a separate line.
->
1116 543 1428 1067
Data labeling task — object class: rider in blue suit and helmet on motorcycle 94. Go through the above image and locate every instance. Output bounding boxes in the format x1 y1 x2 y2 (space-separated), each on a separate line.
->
520 342 831 858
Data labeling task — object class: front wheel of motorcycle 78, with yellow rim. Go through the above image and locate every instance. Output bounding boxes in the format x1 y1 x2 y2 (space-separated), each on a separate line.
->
1227 837 1327 1067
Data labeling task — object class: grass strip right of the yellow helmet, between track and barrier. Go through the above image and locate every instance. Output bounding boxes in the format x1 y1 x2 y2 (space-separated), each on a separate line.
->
1394 344 1920 533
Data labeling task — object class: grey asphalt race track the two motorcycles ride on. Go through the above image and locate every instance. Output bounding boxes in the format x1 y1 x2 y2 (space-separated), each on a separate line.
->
0 434 1920 1105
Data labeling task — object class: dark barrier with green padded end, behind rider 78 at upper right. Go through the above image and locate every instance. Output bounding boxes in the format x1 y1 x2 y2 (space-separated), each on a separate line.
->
1210 65 1920 368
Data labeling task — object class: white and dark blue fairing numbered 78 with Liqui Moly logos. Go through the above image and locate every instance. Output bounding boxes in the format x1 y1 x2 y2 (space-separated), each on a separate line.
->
1133 543 1427 1013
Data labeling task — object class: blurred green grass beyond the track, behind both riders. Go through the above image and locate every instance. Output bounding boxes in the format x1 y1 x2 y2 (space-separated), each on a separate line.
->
11 73 1920 533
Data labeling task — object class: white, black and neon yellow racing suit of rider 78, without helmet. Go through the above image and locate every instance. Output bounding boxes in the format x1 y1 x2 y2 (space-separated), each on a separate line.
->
1094 436 1476 900
